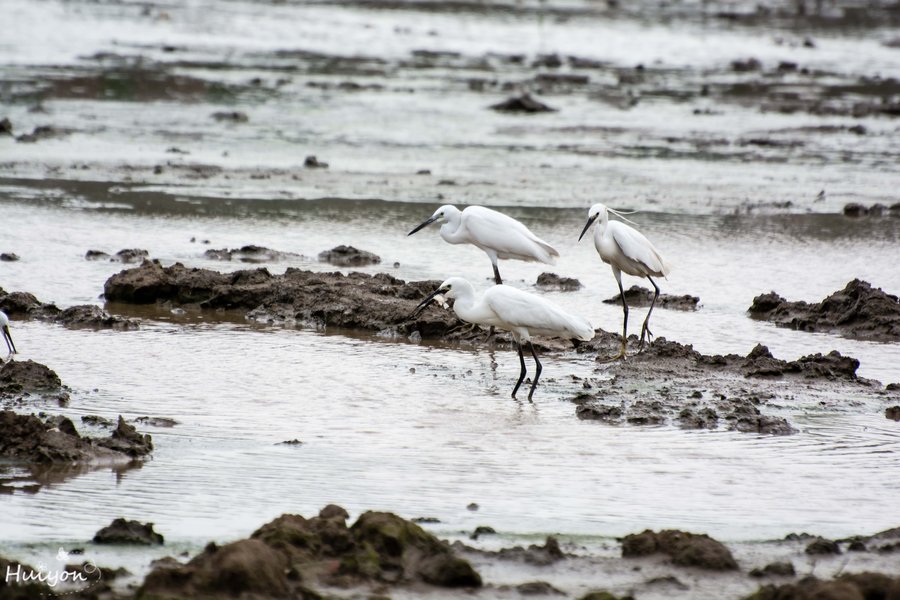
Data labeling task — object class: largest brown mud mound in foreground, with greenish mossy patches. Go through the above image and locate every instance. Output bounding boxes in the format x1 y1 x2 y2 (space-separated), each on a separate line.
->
139 506 481 598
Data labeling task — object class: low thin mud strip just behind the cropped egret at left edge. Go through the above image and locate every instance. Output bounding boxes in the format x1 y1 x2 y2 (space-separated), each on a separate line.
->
0 288 139 330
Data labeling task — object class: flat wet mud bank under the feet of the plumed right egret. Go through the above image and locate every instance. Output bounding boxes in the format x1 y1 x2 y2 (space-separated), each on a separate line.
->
572 333 900 435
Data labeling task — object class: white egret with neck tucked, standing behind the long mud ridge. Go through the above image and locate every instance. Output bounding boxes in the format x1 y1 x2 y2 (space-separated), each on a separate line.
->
407 204 559 284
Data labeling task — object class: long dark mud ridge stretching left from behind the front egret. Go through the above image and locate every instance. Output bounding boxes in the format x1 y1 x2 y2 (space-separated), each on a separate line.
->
104 261 459 338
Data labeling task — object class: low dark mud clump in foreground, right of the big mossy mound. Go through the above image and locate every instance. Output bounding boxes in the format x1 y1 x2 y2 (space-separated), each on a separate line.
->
622 529 738 571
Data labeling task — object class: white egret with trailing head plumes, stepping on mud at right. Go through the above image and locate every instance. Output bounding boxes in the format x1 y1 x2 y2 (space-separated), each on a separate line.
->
578 204 670 360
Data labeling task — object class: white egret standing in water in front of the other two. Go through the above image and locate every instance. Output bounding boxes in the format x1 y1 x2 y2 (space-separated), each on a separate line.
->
412 277 594 400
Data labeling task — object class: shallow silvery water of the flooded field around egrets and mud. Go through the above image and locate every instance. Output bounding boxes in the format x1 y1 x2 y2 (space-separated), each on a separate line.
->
0 0 900 580
